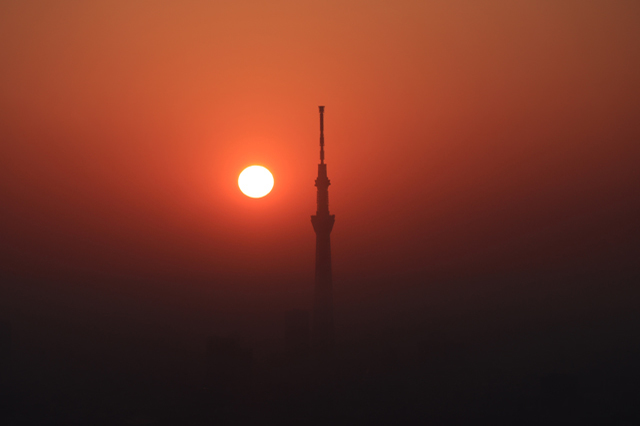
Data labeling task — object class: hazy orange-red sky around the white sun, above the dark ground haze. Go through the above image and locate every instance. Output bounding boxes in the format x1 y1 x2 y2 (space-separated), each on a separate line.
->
0 0 640 340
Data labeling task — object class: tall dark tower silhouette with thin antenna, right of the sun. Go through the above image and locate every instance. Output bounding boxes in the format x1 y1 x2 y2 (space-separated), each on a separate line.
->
311 106 335 353
